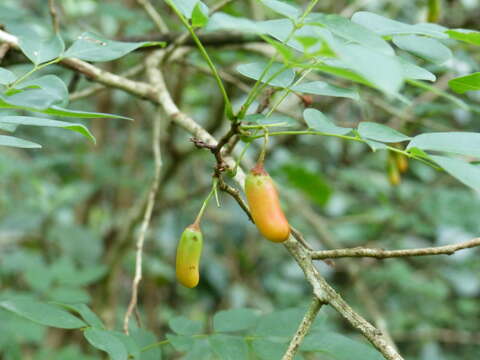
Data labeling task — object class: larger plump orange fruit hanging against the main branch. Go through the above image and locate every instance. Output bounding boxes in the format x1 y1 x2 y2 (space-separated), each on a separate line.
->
245 164 290 242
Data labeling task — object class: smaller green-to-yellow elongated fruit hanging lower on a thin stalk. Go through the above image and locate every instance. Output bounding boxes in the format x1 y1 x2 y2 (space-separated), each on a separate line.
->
176 224 203 288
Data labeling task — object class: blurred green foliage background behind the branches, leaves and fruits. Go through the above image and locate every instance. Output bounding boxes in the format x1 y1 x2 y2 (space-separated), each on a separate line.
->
0 0 480 360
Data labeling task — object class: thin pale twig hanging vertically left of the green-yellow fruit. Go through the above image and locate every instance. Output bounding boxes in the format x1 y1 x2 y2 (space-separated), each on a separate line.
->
123 108 162 335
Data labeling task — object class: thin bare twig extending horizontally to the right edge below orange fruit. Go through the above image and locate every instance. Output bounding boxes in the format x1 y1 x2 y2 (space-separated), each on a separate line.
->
312 238 480 260
